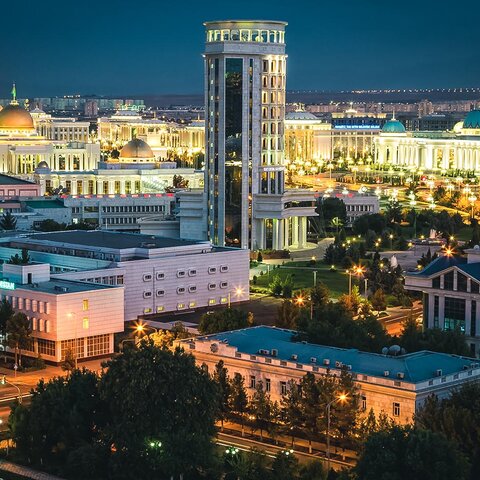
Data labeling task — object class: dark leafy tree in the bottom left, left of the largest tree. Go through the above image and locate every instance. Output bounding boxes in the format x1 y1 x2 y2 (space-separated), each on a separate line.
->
9 369 109 479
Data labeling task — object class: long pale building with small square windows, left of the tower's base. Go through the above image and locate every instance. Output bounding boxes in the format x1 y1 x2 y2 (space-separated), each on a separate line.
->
0 230 249 321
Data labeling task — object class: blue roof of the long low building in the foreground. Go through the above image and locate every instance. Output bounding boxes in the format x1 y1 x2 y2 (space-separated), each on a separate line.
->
199 326 475 383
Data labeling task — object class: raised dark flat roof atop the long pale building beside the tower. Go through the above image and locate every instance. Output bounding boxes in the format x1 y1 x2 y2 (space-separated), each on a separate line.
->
28 230 202 250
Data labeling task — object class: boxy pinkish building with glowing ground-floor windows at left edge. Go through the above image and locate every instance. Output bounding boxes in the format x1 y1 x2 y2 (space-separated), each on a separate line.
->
0 262 124 363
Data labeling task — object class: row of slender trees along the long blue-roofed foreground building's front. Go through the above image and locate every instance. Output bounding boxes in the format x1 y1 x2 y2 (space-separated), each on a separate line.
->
213 361 359 453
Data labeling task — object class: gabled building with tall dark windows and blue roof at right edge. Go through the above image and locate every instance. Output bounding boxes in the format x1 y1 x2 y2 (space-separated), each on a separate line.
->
405 246 480 357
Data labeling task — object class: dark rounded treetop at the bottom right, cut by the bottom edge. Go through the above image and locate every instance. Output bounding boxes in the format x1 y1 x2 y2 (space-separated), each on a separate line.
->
354 425 468 480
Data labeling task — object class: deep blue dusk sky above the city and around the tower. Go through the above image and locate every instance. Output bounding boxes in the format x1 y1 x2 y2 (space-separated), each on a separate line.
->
0 0 480 98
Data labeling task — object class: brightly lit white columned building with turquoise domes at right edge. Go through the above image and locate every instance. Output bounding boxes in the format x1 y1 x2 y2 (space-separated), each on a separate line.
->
375 110 480 172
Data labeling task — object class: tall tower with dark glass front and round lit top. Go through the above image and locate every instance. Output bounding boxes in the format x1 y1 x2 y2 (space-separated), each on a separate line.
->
204 21 314 249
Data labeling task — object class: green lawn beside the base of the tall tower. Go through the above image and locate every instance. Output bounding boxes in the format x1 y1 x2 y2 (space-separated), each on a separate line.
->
256 262 348 298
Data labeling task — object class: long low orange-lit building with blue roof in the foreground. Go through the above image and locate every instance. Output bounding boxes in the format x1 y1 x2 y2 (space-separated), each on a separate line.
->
179 326 480 423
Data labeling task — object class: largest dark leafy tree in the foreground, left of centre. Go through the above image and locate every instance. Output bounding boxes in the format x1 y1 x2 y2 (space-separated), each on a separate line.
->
100 340 218 480
